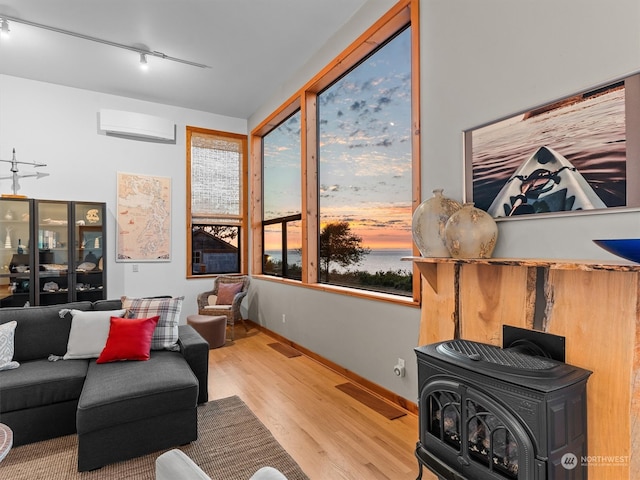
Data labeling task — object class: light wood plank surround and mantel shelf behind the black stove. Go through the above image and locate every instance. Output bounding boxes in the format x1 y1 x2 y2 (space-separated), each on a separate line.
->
406 257 640 480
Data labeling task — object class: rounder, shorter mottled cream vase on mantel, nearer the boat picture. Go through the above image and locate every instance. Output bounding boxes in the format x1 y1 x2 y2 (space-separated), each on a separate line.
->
444 202 498 258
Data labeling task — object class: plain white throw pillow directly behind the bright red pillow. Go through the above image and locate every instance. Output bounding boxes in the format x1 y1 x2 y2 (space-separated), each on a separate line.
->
62 309 126 360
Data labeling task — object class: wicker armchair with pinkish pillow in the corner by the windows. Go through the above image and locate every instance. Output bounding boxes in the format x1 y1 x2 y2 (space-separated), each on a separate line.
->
197 275 249 340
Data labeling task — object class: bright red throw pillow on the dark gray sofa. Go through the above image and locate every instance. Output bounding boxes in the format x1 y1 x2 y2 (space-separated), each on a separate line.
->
96 315 160 363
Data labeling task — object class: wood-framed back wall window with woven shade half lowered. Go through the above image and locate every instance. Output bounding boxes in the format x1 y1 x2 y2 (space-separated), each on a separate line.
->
187 127 247 277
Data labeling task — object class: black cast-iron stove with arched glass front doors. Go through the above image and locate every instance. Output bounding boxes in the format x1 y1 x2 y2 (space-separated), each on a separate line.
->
415 340 591 480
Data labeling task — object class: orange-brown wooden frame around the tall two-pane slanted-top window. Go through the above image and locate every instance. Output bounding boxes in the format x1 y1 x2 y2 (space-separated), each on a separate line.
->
249 0 421 305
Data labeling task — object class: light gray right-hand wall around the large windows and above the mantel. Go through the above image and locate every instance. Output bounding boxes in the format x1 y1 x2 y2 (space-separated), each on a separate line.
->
249 0 640 401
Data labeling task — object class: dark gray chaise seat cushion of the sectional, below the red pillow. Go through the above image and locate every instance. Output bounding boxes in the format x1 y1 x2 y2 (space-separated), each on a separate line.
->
76 351 198 434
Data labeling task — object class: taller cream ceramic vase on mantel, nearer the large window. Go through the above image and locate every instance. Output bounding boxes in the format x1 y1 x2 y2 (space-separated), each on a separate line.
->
411 188 462 257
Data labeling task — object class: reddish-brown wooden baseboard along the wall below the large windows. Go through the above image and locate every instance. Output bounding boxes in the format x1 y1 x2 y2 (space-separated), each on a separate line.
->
245 320 418 415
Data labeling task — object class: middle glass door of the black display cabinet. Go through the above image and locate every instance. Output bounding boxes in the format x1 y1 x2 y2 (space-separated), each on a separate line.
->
35 200 70 305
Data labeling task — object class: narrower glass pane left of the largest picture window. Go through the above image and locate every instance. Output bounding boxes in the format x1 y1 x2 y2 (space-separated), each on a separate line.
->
262 110 302 280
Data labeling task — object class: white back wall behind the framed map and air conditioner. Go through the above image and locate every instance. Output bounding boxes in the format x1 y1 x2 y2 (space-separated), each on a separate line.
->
0 75 247 321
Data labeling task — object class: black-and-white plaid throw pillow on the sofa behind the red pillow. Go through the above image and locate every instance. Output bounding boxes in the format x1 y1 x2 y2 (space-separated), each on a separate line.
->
121 296 184 351
